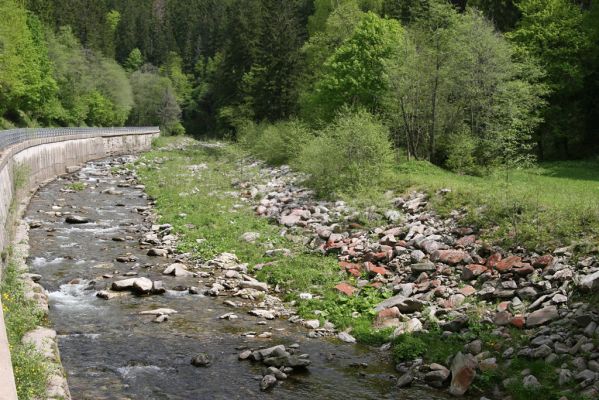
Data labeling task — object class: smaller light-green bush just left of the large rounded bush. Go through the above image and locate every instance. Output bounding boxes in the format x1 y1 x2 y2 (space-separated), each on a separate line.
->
253 120 314 165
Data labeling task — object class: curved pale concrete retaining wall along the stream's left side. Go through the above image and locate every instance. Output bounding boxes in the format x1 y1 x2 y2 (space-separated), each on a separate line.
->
0 128 160 400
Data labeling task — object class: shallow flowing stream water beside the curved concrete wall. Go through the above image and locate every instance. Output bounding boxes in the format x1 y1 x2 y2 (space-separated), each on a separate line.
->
27 158 452 400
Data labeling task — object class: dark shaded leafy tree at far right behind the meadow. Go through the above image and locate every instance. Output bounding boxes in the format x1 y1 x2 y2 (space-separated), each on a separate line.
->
508 0 599 157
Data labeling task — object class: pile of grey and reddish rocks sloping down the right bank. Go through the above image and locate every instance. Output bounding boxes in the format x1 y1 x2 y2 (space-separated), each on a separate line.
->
235 159 599 396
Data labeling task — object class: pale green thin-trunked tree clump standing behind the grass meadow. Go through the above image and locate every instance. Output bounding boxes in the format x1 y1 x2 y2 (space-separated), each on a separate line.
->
386 3 544 172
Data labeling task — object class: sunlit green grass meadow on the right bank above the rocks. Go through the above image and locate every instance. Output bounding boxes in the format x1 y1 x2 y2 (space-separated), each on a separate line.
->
346 161 599 252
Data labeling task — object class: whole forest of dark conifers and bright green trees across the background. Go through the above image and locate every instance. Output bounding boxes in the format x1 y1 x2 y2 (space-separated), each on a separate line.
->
0 0 599 169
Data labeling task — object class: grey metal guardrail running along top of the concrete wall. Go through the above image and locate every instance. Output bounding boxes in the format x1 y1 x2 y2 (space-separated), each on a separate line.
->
0 126 160 153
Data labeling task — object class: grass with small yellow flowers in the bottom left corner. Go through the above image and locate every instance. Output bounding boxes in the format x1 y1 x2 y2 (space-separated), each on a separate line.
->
0 250 50 400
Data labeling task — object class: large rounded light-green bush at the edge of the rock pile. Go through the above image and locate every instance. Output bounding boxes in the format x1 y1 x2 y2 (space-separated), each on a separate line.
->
298 111 393 197
